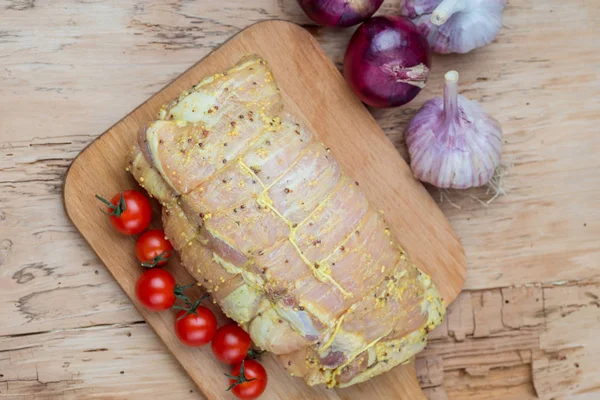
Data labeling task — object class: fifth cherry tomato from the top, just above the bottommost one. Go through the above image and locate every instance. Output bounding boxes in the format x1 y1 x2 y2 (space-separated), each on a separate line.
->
211 324 251 364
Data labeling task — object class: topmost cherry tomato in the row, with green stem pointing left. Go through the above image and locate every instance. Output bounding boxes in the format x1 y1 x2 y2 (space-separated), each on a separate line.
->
96 190 152 235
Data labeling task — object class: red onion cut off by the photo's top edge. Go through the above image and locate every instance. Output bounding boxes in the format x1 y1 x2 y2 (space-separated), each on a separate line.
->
298 0 383 27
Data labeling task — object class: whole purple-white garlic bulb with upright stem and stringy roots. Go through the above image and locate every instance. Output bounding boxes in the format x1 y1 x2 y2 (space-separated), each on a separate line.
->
405 71 502 189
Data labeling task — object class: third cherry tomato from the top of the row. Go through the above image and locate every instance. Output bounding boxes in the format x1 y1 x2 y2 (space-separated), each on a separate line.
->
135 268 176 311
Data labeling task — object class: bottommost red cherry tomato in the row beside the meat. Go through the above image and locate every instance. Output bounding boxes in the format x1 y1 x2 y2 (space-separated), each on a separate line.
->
227 360 267 400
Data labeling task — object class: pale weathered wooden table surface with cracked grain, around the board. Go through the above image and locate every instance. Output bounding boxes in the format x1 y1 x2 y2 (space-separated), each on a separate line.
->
0 0 600 400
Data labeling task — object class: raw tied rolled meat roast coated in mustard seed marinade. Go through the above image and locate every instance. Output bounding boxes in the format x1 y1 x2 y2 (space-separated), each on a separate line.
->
127 56 445 387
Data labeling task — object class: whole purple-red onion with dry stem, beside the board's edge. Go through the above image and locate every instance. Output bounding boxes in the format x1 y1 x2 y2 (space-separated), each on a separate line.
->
344 16 431 107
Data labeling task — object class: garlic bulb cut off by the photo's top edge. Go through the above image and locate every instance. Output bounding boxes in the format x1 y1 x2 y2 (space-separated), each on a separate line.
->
400 0 506 54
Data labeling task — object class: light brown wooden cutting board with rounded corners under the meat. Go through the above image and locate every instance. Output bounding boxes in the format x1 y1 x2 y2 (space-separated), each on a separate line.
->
64 21 465 399
